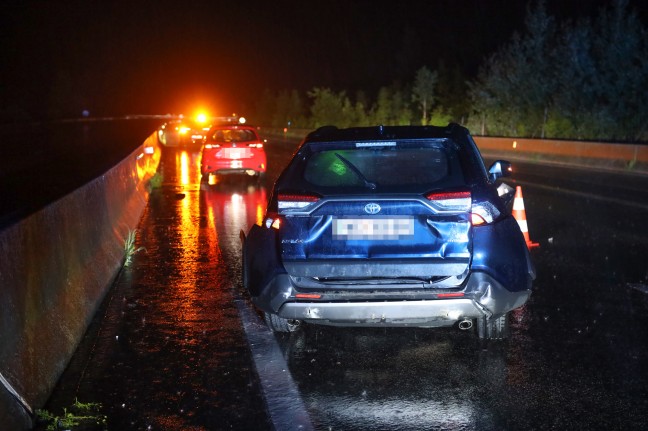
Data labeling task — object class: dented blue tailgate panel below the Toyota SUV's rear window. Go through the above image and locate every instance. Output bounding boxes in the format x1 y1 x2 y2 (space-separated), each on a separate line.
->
281 196 471 278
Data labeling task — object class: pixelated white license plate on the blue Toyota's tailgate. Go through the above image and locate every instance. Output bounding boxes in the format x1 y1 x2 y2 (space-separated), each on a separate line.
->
333 217 414 240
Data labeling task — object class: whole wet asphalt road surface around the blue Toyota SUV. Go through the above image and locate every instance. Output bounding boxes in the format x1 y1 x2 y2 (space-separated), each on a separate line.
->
41 142 648 430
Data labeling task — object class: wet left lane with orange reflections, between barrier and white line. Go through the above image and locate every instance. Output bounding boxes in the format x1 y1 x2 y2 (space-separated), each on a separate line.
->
40 147 270 430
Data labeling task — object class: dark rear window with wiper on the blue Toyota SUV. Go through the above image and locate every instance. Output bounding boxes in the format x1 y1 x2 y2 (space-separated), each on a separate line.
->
303 141 460 188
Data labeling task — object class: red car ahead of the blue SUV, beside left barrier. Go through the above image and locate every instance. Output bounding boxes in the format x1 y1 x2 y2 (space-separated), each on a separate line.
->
200 124 266 181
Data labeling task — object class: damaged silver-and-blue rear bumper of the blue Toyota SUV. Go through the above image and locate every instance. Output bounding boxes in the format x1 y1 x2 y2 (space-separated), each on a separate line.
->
253 272 531 327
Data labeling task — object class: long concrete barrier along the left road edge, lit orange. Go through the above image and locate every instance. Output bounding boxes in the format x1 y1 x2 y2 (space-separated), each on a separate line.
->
0 133 160 430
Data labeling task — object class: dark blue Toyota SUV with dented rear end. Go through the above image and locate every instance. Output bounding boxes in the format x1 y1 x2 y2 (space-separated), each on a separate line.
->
241 124 535 339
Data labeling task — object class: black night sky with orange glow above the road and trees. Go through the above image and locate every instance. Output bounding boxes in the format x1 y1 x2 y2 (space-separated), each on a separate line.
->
0 0 633 119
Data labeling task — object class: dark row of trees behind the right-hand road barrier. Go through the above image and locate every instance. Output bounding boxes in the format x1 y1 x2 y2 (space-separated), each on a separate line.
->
255 0 648 142
